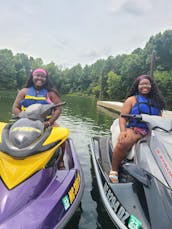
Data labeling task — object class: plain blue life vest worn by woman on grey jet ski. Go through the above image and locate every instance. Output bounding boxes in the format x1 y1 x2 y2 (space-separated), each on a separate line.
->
127 95 160 129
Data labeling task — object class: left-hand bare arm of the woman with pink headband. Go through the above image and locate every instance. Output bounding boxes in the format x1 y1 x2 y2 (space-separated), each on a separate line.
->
12 88 27 115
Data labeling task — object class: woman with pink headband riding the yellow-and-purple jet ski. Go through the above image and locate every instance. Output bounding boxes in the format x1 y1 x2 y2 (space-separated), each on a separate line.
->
12 68 65 169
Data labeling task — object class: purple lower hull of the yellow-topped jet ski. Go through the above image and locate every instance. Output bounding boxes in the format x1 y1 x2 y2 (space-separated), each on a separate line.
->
0 139 84 229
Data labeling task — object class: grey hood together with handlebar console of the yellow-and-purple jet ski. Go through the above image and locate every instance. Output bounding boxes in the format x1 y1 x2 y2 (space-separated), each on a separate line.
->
0 102 65 158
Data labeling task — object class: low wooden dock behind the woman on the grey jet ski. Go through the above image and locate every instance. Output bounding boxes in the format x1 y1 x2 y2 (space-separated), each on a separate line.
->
97 101 172 118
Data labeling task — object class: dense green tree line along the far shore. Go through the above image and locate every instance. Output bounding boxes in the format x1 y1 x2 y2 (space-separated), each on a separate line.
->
0 30 172 104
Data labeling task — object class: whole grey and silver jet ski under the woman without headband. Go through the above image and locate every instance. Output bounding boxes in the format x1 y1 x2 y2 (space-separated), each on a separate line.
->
90 115 172 229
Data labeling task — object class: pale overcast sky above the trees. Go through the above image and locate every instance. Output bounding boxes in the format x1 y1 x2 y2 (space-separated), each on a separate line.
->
0 0 172 67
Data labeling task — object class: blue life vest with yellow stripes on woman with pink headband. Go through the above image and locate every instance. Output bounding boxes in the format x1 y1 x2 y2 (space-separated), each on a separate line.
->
20 87 49 111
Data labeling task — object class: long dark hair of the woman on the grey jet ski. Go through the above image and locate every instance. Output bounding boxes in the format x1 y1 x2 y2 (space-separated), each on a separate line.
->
127 75 166 111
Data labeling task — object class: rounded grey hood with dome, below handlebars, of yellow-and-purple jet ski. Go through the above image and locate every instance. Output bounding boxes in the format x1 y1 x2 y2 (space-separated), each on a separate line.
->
0 118 50 158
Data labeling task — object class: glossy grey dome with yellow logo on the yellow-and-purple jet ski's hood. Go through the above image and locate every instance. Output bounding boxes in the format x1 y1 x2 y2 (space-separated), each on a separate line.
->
9 118 44 149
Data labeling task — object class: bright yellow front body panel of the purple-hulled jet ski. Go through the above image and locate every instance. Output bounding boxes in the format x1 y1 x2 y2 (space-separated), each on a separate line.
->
0 123 69 189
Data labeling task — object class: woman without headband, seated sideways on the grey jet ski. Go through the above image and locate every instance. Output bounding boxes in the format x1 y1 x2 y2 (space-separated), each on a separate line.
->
109 75 165 183
